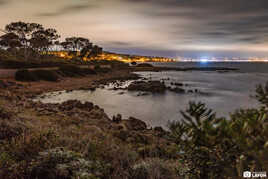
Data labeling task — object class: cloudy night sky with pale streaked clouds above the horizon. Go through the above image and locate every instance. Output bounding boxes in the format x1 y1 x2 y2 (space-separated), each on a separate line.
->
0 0 268 58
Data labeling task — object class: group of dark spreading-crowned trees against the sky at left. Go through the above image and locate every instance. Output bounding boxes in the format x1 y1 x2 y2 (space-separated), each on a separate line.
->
0 22 102 60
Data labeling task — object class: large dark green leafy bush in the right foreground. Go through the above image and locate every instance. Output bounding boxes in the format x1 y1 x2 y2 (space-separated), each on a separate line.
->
169 86 268 178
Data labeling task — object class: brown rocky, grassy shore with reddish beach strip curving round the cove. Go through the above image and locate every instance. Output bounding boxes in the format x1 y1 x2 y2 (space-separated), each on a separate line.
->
0 70 182 178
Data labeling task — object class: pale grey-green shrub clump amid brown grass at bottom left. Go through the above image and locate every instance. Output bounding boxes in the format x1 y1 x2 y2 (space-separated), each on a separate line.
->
30 148 106 179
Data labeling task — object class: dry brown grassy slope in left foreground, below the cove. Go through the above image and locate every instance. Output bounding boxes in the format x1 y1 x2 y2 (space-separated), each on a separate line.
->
0 91 180 179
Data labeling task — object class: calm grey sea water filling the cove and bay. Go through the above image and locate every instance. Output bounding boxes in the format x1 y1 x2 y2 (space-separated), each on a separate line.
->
34 62 268 127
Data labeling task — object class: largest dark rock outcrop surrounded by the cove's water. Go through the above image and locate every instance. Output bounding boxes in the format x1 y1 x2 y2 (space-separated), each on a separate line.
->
127 81 166 93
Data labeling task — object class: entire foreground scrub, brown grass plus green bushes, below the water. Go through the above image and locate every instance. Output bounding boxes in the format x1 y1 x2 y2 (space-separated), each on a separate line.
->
0 77 268 179
